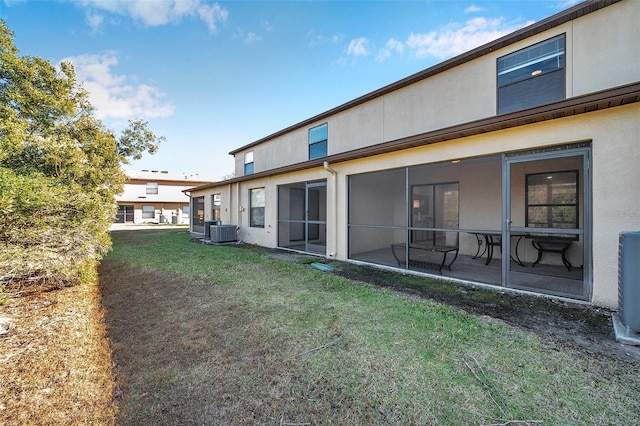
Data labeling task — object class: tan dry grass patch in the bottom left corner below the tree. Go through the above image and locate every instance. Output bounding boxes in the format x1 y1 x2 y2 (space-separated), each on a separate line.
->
0 284 117 425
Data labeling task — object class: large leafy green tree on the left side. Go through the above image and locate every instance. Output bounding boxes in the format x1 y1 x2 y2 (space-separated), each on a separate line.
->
0 20 164 292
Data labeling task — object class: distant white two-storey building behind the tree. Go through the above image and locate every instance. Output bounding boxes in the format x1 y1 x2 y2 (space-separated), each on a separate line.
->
114 170 211 224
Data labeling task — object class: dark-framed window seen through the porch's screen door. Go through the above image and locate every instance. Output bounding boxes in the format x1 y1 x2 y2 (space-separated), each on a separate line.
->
526 170 578 235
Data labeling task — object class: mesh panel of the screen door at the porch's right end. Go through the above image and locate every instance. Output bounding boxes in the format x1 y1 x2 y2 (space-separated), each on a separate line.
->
509 151 589 299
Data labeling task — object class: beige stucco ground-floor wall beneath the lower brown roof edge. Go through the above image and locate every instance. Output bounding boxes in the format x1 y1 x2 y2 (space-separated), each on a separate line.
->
194 103 640 309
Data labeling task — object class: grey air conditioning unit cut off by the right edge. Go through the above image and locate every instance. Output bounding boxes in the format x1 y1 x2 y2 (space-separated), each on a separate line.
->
613 232 640 345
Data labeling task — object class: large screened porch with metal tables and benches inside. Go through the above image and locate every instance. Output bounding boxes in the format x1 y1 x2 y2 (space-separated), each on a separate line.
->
348 146 590 299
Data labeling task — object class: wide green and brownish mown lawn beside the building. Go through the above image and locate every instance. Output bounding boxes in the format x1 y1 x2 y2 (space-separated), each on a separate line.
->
101 231 640 425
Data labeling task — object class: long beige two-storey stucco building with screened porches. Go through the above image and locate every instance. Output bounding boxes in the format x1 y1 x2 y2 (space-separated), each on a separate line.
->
184 0 640 309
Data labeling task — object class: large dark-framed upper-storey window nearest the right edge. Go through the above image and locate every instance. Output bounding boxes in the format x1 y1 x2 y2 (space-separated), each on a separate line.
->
496 33 567 115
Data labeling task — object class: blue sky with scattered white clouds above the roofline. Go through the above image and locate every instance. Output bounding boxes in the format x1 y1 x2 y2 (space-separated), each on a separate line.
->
0 0 579 180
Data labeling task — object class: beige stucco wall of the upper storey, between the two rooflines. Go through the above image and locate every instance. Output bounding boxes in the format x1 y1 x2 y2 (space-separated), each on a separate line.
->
236 0 640 176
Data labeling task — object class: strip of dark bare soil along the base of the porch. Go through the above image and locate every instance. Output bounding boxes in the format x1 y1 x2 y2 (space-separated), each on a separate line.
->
258 251 640 364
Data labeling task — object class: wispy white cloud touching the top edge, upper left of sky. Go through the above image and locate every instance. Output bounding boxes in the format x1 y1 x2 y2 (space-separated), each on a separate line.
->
75 0 229 31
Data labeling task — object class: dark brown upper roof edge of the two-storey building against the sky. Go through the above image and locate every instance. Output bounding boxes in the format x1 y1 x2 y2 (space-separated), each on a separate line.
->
229 0 622 155
